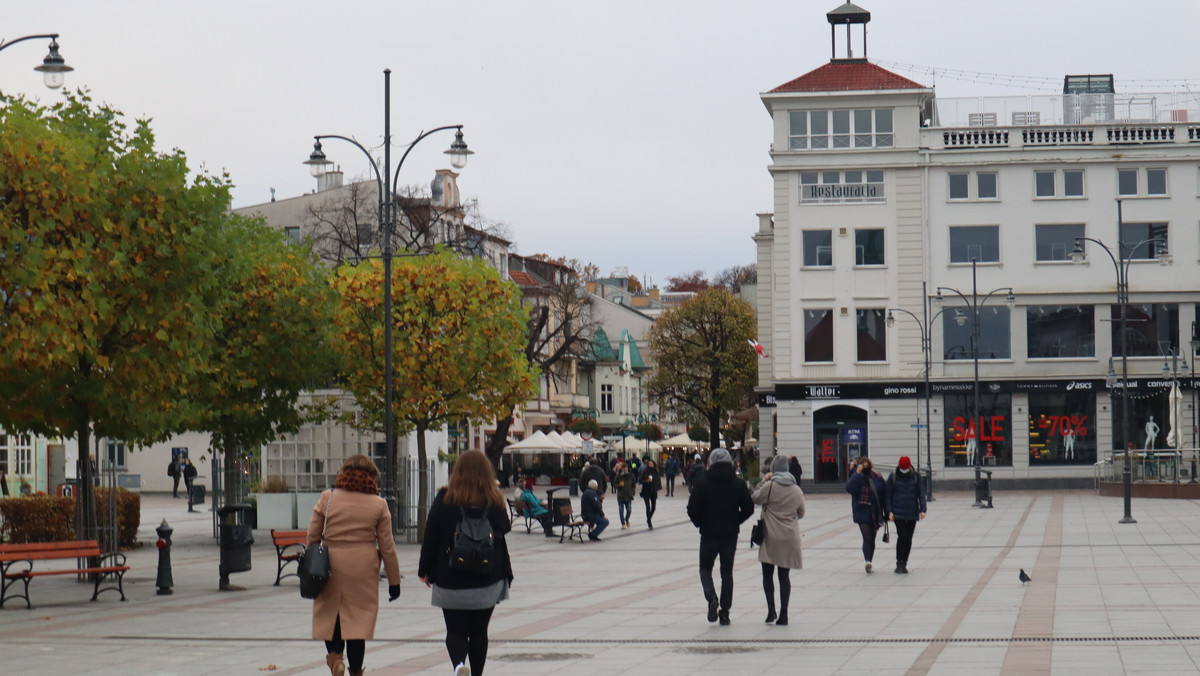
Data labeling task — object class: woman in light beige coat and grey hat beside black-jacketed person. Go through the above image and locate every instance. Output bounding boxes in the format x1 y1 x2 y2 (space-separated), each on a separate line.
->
750 455 804 624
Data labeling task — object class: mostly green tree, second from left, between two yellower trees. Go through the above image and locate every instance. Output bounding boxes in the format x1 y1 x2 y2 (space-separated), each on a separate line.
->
191 216 335 504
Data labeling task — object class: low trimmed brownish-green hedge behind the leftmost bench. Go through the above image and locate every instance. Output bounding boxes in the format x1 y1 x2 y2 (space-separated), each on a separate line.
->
0 489 142 549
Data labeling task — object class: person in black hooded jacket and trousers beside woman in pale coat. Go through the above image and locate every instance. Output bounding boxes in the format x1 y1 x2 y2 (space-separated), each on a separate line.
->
688 448 754 624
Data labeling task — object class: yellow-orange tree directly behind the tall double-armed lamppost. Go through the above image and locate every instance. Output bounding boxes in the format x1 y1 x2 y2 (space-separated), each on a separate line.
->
334 249 536 537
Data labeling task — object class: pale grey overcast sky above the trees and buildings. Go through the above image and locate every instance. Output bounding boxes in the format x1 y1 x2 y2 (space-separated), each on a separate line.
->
0 0 1200 283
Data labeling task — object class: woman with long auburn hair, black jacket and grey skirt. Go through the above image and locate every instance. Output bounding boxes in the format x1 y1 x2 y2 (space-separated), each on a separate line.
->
418 450 512 676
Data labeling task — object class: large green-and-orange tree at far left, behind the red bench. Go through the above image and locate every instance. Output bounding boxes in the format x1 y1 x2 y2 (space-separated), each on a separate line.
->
0 92 229 539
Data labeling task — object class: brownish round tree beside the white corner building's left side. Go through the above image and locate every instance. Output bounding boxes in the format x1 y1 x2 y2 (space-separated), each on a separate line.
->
646 288 757 447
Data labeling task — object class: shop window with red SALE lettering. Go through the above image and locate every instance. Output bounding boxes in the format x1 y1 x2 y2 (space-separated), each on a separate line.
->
942 388 1013 467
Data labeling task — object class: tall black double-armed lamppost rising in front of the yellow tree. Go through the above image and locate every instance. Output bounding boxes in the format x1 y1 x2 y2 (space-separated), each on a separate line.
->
304 68 474 527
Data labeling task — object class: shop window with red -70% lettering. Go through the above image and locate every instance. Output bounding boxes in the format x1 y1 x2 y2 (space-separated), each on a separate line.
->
1030 391 1096 465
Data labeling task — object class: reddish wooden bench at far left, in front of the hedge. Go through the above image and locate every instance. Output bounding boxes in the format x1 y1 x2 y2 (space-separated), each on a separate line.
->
0 540 130 609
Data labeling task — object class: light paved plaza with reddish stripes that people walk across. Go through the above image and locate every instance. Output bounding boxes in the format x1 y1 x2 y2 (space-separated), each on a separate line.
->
0 490 1200 676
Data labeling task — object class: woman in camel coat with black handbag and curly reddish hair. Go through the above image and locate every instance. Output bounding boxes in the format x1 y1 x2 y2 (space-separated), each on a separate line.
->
307 455 400 676
